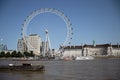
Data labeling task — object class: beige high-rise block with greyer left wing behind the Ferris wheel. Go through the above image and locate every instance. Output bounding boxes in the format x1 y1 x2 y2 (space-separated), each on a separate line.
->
17 34 42 55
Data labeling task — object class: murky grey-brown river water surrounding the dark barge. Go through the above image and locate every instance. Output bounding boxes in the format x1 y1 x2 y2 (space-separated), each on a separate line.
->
0 59 120 80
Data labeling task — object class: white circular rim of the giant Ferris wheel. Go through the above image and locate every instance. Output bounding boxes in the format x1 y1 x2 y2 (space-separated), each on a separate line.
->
22 8 73 53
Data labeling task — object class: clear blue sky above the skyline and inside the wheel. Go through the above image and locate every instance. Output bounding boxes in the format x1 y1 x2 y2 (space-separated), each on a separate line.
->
0 0 120 49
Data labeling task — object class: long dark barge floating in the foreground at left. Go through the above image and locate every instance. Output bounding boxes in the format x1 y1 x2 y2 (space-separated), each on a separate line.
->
0 63 45 71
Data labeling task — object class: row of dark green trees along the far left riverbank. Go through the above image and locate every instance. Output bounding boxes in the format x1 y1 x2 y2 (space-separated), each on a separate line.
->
0 51 35 58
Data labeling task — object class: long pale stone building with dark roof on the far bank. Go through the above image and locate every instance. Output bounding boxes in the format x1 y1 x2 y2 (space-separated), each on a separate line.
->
63 44 120 57
